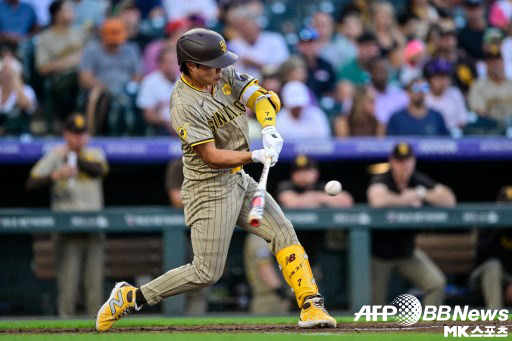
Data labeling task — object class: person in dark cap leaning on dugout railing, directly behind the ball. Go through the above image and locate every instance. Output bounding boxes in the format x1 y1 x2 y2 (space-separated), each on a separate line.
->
276 155 354 208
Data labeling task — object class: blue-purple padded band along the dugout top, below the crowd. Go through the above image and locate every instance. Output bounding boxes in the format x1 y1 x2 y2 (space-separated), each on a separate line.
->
0 137 512 164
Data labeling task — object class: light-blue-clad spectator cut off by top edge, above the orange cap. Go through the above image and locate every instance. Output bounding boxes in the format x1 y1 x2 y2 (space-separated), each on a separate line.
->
71 0 109 33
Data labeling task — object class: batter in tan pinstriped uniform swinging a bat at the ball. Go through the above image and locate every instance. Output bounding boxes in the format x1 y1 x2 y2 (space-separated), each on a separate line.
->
96 28 336 331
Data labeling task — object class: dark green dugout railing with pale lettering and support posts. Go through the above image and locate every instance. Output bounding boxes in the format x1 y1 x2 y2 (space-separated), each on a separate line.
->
0 203 512 314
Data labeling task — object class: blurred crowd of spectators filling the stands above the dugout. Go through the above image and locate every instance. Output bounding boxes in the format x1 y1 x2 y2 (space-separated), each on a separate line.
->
0 0 512 139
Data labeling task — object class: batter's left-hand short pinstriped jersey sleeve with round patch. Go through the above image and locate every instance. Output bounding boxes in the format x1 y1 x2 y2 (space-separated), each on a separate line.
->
171 104 214 147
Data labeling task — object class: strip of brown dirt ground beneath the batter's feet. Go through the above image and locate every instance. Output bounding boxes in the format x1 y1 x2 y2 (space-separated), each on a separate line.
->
0 321 512 335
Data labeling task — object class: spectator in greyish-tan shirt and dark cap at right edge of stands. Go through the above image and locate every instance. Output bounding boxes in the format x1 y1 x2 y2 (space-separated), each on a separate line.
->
468 46 512 130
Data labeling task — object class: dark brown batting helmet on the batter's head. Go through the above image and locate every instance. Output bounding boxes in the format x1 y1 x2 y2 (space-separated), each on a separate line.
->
176 28 238 68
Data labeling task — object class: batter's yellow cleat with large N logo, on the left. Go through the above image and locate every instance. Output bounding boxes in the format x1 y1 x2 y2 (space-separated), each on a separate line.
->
96 282 141 332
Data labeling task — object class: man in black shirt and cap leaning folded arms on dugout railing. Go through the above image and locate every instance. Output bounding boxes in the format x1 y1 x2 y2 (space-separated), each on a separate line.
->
367 142 456 306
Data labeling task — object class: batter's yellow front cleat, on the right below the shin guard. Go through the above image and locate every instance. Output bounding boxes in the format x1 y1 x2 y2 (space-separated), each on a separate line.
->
299 295 336 328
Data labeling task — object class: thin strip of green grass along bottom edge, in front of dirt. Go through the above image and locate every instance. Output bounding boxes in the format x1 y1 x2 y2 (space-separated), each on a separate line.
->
0 333 446 341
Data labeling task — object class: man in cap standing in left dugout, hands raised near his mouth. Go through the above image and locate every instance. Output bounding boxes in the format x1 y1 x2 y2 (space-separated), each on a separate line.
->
27 114 108 317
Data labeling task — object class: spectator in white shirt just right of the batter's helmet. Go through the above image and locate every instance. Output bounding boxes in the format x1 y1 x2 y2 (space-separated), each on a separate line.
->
229 6 289 79
